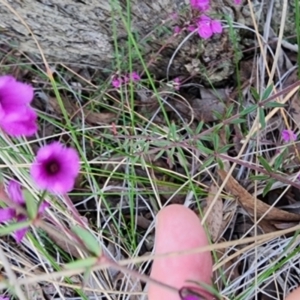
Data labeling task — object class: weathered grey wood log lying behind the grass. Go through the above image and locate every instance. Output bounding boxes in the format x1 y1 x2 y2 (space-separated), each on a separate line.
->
0 0 295 82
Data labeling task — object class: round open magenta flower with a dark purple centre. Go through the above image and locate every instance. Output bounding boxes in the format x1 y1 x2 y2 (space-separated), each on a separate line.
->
30 142 80 194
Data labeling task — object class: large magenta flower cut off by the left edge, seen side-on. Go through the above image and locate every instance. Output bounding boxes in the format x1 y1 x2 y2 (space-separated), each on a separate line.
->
0 76 37 136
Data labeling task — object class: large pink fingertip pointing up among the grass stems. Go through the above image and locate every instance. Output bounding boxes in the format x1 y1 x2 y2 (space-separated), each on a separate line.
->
148 204 212 300
